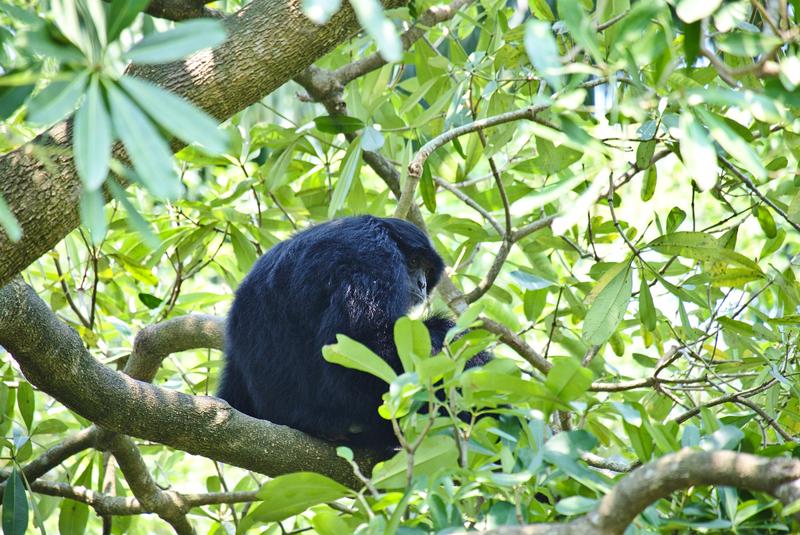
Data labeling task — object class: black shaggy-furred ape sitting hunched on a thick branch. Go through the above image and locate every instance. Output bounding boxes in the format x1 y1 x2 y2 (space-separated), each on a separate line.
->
219 216 488 449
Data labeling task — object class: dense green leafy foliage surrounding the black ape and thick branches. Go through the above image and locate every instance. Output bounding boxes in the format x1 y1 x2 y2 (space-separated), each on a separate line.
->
0 0 800 534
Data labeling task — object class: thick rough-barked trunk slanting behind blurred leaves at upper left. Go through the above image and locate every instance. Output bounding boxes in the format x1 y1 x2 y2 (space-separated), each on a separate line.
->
0 0 404 285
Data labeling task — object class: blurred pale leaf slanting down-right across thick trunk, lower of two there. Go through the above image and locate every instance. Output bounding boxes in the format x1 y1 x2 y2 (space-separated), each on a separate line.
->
119 76 228 155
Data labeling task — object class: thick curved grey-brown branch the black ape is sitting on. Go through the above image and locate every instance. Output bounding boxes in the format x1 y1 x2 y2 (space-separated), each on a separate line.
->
0 279 377 487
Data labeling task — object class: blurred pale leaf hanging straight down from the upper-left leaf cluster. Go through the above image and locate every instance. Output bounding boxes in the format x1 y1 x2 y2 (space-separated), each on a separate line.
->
72 77 113 191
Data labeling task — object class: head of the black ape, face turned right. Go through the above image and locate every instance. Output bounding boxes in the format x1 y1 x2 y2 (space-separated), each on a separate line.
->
380 218 444 307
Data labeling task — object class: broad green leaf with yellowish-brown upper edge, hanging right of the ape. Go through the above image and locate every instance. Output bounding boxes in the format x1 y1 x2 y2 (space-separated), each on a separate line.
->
583 263 633 345
